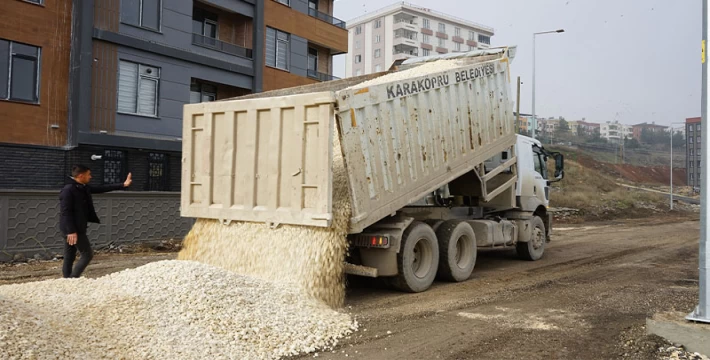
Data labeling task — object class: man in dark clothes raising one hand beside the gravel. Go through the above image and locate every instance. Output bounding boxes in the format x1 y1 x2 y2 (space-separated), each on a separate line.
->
59 165 132 278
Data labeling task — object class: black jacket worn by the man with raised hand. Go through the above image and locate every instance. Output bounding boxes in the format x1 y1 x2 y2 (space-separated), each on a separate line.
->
59 179 123 235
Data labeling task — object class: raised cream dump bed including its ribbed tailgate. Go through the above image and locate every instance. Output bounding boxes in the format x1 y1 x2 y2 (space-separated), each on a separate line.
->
181 48 515 233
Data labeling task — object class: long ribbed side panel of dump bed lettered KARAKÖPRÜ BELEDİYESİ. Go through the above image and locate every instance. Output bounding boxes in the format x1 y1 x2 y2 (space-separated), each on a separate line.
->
337 58 515 233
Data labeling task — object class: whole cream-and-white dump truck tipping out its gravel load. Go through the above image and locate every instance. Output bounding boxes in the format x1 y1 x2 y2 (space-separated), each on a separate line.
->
181 47 564 292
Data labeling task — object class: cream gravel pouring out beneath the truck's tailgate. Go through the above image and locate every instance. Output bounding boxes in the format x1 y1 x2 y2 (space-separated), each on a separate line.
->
178 125 351 308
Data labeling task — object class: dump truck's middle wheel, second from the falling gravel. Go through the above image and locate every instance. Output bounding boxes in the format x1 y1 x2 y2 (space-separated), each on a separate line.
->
436 220 478 282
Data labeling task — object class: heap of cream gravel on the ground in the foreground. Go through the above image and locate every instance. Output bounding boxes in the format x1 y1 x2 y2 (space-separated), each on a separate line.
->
0 260 357 359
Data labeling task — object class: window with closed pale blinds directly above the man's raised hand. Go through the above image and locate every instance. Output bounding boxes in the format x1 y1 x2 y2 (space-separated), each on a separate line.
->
118 60 160 116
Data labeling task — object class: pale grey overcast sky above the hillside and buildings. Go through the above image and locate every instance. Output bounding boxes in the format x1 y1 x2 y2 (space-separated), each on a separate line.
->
334 0 702 125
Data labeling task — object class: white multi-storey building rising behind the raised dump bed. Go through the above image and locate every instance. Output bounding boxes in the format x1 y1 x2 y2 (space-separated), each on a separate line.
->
345 2 493 77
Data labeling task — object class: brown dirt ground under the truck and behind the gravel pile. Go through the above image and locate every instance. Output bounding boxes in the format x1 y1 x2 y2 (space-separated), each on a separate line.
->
0 214 699 359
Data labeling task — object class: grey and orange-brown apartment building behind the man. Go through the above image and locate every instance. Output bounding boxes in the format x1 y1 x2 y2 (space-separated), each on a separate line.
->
0 0 348 191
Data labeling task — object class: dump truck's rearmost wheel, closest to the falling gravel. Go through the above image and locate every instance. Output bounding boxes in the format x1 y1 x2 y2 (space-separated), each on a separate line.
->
392 222 439 292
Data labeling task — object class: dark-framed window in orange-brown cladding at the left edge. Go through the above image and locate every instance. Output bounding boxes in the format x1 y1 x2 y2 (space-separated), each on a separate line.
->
0 39 41 103
